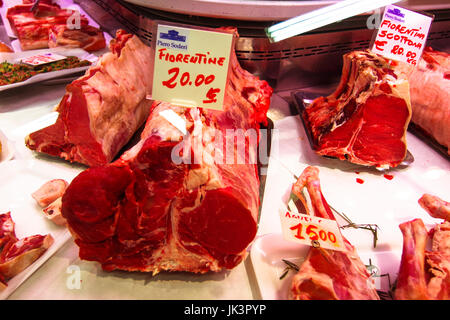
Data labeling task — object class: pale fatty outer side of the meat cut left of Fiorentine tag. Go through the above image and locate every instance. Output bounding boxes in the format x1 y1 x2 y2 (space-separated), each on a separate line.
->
83 37 151 159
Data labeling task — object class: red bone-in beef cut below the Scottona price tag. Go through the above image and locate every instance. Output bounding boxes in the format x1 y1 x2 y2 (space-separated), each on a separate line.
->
303 51 411 168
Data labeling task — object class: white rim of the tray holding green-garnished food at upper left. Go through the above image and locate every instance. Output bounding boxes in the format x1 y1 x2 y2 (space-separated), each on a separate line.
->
0 47 98 92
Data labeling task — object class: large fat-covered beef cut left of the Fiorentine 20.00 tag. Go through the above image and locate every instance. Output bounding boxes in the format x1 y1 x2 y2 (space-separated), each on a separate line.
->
26 31 152 166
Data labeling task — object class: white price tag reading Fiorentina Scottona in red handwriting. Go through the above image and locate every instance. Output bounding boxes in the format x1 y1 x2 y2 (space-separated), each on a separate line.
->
371 5 433 66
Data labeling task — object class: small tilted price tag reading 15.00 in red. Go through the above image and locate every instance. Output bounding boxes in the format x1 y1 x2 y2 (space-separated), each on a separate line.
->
280 210 346 251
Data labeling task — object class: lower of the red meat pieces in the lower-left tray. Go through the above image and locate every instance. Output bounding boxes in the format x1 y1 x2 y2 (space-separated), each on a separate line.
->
0 234 53 279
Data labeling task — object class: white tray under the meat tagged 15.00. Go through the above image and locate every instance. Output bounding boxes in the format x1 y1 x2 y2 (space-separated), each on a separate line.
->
250 116 450 299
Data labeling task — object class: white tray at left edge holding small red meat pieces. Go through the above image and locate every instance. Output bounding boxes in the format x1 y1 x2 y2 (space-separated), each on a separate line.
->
0 160 81 299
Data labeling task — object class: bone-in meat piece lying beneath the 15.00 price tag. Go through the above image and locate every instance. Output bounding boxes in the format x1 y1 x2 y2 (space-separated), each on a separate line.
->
289 167 380 300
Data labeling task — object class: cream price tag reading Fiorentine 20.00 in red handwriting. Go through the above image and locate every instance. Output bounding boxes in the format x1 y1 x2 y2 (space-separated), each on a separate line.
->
152 24 234 110
